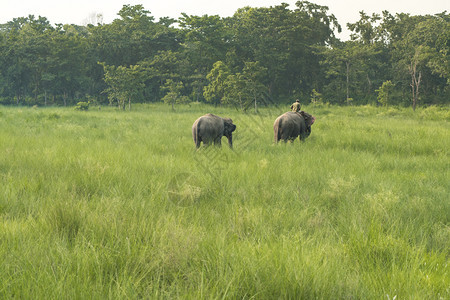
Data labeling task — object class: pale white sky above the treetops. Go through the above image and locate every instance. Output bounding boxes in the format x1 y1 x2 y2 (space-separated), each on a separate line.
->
0 0 450 39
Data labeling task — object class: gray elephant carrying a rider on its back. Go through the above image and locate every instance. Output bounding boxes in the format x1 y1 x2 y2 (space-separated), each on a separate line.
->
273 111 316 143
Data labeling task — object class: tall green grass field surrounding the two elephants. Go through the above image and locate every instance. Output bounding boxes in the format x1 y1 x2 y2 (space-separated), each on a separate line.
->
0 104 450 300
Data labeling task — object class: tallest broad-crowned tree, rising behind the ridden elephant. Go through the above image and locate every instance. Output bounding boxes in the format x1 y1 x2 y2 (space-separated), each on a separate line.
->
229 1 340 98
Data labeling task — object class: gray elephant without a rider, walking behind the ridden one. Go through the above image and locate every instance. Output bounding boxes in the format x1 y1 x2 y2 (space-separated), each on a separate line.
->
192 114 236 148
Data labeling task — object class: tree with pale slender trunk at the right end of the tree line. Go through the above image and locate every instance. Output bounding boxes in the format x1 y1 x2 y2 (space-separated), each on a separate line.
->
380 13 450 110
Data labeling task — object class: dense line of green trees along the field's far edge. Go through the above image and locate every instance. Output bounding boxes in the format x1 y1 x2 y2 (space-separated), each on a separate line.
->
0 1 450 110
